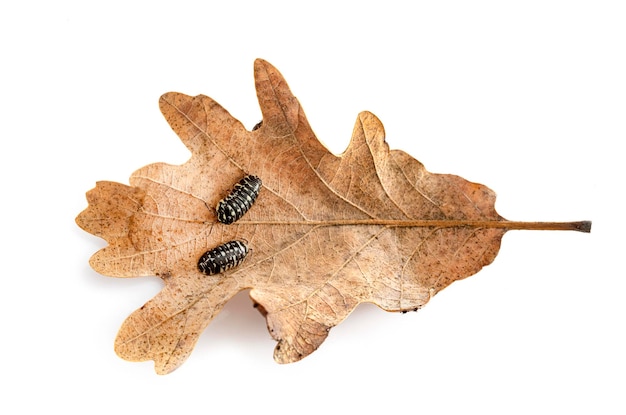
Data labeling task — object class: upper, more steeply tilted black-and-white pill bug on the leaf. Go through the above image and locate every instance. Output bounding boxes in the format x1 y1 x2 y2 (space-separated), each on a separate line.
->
215 175 262 225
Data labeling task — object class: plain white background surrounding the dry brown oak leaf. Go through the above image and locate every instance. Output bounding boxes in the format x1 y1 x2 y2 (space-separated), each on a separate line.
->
0 0 626 414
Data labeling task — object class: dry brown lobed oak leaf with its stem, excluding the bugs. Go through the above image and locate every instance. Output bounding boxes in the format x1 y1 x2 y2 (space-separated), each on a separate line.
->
76 60 590 374
